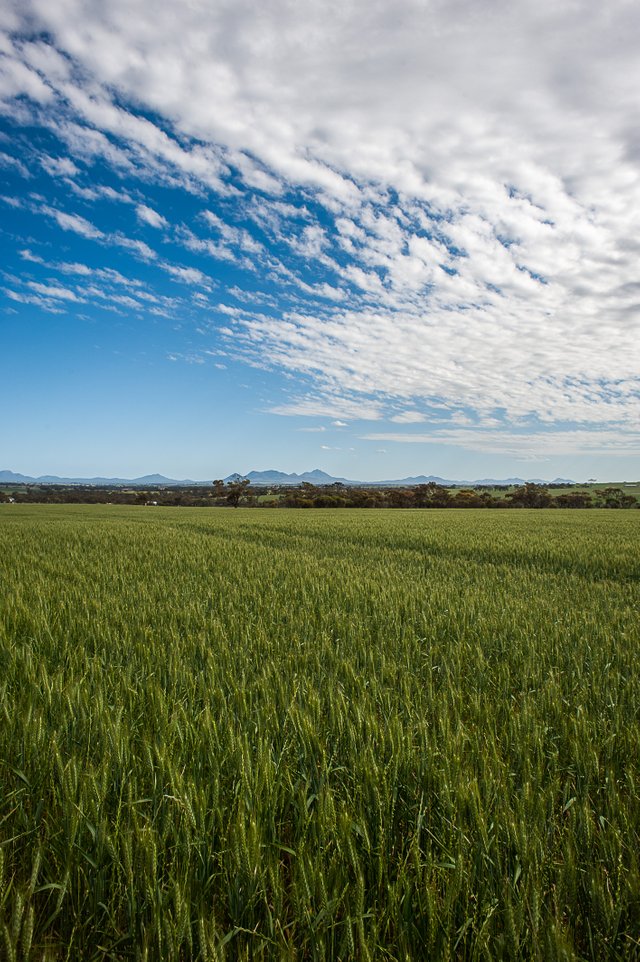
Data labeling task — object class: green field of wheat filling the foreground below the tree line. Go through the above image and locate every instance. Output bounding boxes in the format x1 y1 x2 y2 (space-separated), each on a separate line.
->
0 504 640 962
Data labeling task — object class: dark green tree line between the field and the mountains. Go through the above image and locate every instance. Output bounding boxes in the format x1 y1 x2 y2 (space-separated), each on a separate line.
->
0 479 640 509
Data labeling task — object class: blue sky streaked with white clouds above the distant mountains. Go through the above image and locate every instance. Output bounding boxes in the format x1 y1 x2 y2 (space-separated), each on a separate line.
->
0 0 640 481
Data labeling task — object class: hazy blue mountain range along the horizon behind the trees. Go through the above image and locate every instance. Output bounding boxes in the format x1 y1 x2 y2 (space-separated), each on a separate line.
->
0 468 575 488
